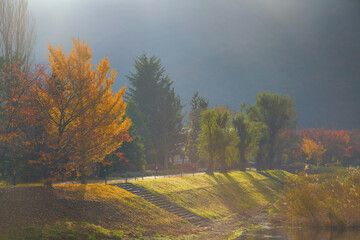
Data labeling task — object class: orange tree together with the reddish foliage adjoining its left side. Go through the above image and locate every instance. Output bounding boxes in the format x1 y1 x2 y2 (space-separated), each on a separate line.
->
1 40 131 186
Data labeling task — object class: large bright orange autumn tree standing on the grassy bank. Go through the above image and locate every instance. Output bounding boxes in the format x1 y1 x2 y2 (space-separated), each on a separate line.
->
32 39 131 186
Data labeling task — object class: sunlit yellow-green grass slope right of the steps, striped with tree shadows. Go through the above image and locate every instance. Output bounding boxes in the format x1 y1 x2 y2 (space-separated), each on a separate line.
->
131 170 290 218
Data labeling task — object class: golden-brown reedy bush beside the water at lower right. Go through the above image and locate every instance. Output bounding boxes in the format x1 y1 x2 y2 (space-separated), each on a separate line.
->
278 168 360 228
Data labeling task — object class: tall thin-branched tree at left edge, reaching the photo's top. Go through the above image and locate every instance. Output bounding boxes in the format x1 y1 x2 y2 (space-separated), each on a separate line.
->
0 0 35 180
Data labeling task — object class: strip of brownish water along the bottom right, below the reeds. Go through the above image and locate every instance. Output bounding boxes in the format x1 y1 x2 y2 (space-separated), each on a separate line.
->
236 227 360 240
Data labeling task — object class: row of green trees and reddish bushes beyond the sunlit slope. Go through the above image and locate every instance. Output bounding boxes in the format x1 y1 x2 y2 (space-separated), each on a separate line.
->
183 92 360 173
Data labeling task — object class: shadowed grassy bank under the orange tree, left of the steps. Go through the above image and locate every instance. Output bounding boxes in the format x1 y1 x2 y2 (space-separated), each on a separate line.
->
0 184 191 239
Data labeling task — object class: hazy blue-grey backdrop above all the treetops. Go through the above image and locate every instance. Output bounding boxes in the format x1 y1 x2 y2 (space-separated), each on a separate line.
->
29 0 360 128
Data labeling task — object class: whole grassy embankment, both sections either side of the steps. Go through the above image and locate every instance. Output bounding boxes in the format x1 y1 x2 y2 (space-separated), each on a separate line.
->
0 171 289 239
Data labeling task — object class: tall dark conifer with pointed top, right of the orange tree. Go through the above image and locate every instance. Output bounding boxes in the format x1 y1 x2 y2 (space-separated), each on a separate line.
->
127 54 184 168
